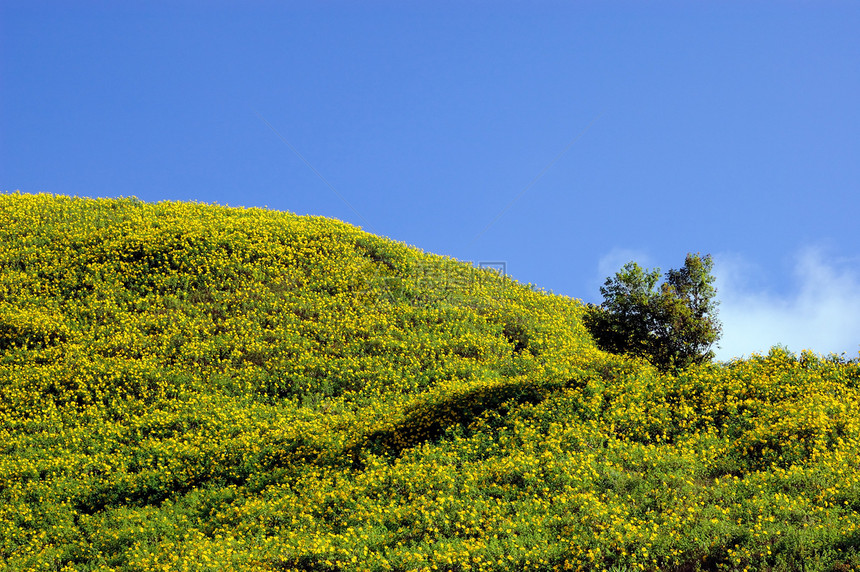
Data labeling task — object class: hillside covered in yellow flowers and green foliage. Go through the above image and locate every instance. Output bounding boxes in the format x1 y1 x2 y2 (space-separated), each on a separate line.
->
0 194 860 571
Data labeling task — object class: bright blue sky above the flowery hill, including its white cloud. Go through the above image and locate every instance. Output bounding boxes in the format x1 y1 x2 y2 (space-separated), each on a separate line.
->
0 0 860 359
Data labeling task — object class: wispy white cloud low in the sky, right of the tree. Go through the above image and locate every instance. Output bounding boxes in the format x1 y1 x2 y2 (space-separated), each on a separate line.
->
714 248 860 360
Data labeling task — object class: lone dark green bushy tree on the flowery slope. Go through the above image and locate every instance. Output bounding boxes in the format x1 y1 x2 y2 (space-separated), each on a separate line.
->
585 254 722 370
